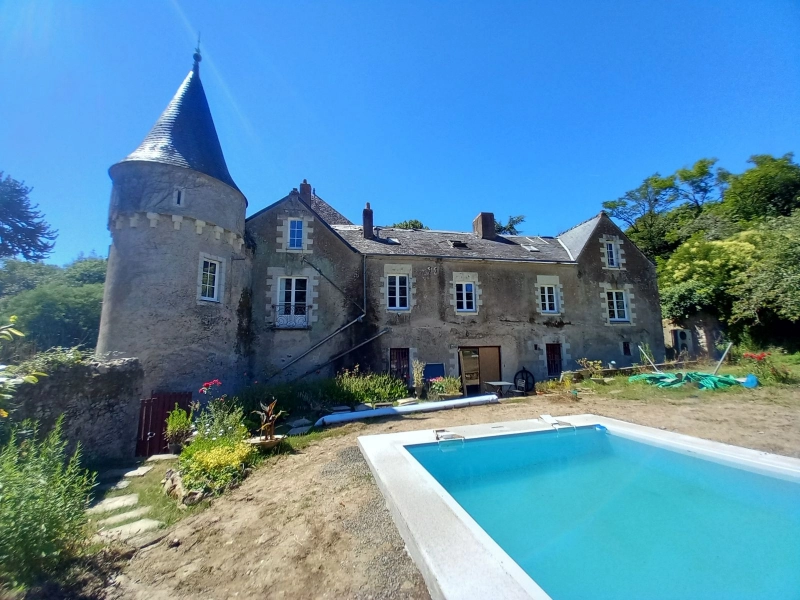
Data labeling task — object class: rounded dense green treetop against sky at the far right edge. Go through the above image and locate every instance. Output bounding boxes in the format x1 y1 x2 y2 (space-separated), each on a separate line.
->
724 153 800 221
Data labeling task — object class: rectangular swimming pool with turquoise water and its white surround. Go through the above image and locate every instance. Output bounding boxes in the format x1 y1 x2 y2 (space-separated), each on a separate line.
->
359 415 800 600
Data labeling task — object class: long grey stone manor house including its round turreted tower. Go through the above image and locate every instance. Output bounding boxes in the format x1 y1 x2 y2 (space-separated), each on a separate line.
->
97 54 664 393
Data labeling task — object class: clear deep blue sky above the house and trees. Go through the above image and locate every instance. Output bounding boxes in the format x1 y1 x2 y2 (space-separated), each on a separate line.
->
0 0 800 263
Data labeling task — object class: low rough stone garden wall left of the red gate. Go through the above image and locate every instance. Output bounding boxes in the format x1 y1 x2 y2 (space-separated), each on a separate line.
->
14 358 144 462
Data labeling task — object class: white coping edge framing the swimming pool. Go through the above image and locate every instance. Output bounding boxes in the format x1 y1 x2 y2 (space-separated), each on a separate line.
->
358 415 800 600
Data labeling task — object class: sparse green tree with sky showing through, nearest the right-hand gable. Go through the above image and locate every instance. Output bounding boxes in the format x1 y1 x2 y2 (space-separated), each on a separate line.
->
603 173 678 260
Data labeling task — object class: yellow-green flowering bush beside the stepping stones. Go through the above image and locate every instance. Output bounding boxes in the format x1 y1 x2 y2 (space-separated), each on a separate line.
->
180 400 256 494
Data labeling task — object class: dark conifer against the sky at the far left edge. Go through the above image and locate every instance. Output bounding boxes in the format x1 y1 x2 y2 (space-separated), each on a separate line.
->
0 171 57 260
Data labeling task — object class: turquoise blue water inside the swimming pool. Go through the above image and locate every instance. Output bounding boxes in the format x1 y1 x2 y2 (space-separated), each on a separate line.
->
406 428 800 600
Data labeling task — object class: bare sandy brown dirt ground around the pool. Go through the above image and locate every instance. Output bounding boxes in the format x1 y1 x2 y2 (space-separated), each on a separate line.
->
107 388 800 600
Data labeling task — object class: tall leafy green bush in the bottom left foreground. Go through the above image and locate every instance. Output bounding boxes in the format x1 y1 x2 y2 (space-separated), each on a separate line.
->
0 419 94 585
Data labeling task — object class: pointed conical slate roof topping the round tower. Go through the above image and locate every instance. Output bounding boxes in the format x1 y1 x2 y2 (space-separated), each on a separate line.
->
115 54 239 190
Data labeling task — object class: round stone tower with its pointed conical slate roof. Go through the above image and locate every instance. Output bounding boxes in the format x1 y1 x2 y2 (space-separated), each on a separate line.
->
97 53 250 392
